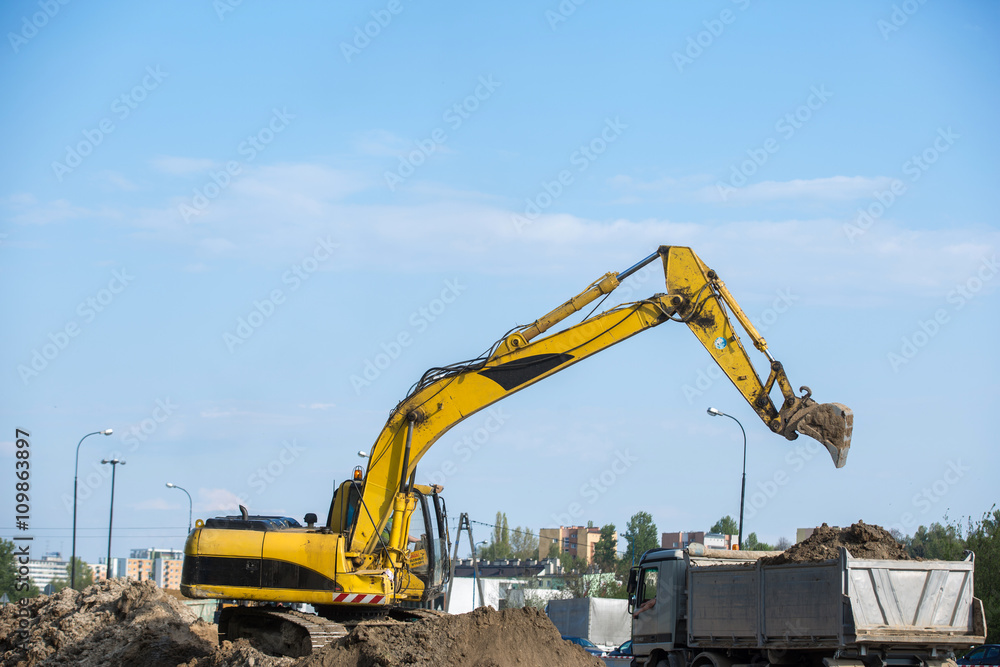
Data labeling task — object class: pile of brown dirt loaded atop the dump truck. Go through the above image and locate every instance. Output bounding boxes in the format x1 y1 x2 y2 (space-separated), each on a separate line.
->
761 521 910 565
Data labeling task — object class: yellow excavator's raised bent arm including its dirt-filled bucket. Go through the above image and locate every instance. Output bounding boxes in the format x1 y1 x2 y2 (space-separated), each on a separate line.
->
348 246 853 554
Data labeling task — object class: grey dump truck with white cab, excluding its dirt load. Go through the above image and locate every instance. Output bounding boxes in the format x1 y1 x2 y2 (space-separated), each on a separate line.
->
627 545 986 667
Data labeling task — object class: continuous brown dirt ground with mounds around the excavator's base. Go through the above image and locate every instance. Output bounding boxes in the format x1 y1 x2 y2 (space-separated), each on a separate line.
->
0 579 603 667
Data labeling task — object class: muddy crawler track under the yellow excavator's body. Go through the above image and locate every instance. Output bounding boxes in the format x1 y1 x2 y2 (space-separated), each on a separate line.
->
219 607 349 658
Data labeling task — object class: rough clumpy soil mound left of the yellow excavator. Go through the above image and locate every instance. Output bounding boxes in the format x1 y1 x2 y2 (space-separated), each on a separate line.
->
0 579 215 667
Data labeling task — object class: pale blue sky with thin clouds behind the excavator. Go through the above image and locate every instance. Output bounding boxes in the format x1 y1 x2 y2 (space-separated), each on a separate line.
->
0 0 1000 561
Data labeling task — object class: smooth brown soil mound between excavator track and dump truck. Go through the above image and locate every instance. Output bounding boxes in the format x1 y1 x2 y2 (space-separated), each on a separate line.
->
296 607 604 667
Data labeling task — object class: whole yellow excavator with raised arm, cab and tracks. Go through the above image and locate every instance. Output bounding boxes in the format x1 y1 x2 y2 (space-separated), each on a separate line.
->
181 246 853 656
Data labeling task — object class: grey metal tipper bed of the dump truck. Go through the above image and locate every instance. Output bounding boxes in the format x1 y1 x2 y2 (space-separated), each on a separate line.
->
687 549 986 648
